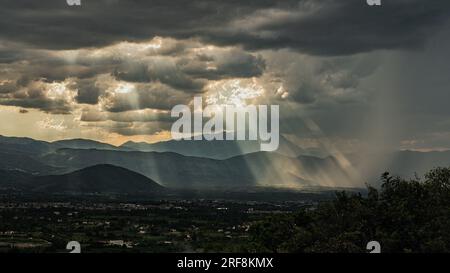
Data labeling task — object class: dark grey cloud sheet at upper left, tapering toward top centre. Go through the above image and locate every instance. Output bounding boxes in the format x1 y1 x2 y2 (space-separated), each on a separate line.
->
0 0 288 49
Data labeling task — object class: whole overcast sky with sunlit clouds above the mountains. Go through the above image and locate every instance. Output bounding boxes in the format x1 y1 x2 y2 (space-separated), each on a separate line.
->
0 0 450 152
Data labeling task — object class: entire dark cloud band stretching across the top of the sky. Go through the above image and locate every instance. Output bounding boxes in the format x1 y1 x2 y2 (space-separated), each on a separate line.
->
0 0 450 55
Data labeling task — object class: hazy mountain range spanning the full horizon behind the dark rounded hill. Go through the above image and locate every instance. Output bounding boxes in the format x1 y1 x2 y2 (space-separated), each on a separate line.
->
0 133 450 192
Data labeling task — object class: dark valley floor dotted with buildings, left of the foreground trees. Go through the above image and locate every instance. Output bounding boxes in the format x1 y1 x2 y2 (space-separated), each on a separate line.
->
0 194 314 253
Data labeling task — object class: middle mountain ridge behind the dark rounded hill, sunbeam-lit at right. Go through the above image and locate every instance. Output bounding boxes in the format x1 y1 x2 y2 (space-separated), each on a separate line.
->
40 149 350 188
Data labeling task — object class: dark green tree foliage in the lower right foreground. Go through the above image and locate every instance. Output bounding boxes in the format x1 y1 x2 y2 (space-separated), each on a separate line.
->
250 168 450 252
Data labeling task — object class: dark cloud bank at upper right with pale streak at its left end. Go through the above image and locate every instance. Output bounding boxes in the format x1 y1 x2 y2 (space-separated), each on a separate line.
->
204 0 450 55
